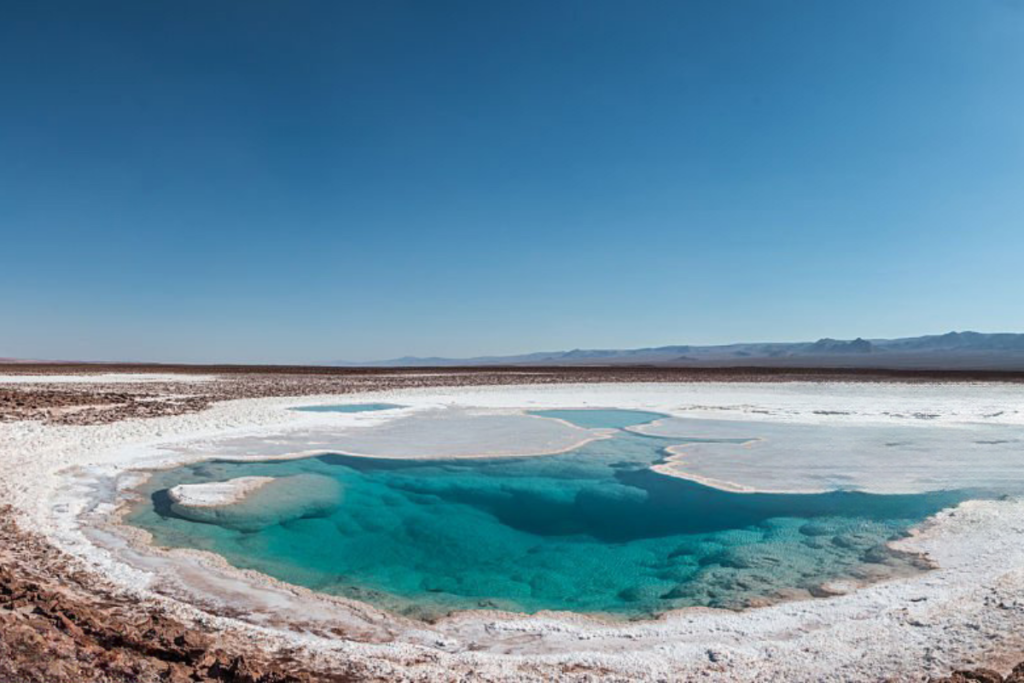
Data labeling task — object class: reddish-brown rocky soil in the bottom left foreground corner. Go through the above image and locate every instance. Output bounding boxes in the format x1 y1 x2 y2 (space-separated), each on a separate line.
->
0 509 362 683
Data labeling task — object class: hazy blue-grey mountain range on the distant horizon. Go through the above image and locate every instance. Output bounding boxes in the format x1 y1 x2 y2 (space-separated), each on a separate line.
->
327 332 1024 370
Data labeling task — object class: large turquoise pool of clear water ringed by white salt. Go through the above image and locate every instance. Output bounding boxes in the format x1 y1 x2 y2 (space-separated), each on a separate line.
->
128 411 965 618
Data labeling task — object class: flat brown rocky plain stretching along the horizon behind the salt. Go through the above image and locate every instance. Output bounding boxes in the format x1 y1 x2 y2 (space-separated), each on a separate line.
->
0 364 1024 424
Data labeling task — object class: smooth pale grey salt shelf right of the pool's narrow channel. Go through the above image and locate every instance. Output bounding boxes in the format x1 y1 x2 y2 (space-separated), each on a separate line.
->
632 418 1024 494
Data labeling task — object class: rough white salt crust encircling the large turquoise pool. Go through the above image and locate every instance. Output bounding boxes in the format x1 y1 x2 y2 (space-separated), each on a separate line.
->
0 376 1024 681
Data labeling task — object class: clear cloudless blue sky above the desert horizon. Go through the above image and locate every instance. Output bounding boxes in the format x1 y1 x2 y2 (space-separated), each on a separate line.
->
0 0 1024 362
